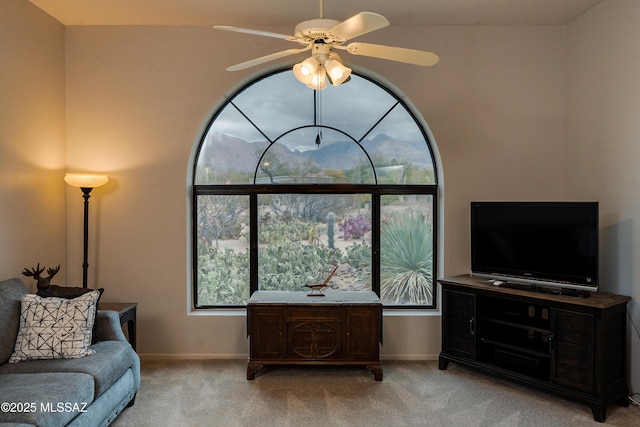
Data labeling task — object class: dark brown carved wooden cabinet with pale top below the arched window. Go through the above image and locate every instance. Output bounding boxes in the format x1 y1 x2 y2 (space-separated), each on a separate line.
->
247 291 382 381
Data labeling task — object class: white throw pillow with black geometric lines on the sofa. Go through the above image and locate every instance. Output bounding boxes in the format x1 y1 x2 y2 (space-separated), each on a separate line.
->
9 290 100 363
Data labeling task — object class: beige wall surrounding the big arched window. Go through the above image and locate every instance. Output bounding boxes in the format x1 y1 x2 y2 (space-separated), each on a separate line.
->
66 26 565 358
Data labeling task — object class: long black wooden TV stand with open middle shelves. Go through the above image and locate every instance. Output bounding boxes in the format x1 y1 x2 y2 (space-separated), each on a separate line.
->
438 275 631 422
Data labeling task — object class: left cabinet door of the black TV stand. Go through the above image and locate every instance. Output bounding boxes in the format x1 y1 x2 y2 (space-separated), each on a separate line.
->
442 289 477 360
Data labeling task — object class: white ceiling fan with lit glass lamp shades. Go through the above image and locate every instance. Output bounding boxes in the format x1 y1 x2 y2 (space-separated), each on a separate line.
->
213 0 440 90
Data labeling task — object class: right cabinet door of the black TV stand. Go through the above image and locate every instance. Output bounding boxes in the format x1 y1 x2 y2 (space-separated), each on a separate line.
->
550 309 595 392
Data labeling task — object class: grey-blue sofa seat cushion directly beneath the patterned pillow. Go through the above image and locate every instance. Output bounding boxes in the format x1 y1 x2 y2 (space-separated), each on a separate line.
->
0 341 138 397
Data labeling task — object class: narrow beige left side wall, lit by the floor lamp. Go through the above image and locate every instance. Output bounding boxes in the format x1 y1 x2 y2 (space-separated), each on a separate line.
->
0 0 66 290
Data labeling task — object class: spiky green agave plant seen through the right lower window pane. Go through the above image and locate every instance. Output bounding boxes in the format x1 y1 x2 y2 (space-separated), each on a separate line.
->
380 210 433 305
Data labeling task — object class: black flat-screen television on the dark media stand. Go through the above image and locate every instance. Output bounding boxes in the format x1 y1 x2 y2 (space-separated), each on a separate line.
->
471 202 599 291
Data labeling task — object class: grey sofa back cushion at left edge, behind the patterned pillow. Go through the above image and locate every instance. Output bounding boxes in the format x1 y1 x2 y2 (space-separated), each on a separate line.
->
0 278 28 364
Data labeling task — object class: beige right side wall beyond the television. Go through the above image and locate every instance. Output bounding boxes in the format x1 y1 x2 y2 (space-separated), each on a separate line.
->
566 0 640 392
